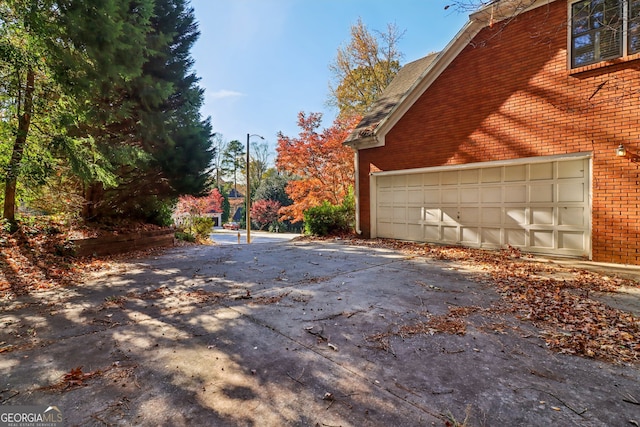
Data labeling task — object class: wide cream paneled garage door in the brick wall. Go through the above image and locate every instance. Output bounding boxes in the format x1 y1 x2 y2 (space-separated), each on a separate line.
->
371 155 591 257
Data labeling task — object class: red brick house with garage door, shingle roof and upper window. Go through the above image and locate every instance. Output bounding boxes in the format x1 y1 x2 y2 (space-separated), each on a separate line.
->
345 0 640 264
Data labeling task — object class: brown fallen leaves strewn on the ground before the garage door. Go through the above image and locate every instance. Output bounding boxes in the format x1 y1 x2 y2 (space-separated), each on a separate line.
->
338 239 640 363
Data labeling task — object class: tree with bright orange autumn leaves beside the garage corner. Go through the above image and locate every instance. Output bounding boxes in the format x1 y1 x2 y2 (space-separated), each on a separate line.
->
276 112 360 222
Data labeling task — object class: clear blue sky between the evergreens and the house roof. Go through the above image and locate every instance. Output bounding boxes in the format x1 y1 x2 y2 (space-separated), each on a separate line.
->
191 0 467 151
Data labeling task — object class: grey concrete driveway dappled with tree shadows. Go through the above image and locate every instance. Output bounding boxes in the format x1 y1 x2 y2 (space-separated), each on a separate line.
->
0 240 640 427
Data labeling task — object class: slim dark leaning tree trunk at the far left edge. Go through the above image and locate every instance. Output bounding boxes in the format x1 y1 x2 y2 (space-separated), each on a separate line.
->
3 67 35 222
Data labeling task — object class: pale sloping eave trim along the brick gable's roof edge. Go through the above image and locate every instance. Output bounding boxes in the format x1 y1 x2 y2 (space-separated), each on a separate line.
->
370 0 556 149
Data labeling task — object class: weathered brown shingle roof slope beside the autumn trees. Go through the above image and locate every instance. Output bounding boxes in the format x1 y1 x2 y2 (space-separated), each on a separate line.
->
344 53 438 144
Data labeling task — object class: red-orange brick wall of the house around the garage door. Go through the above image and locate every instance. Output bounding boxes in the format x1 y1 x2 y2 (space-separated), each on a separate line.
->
358 0 640 264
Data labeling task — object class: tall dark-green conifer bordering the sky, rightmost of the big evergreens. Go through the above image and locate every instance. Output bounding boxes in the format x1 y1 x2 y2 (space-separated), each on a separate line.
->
78 0 213 219
